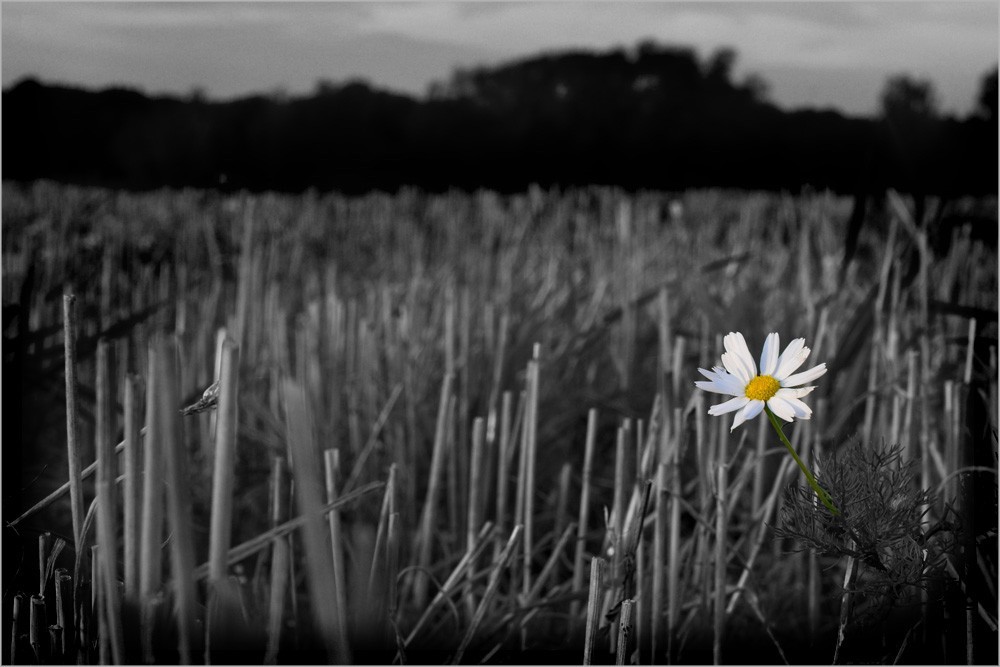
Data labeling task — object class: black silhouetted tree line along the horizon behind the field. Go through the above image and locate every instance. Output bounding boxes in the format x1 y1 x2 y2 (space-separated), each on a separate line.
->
3 43 997 195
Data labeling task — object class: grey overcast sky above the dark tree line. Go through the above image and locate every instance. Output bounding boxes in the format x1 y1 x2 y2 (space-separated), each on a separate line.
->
0 0 1000 115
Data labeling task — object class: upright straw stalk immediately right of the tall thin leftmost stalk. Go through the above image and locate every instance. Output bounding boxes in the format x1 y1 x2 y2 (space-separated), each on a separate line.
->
97 338 125 665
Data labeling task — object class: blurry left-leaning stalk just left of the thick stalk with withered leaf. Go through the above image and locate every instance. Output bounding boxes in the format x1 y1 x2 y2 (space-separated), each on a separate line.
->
155 336 197 664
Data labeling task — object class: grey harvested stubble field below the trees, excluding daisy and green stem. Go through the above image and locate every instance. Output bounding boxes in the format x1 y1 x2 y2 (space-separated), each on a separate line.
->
2 182 998 664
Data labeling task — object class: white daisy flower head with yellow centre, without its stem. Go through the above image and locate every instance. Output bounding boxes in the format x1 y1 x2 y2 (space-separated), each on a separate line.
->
695 332 826 430
